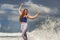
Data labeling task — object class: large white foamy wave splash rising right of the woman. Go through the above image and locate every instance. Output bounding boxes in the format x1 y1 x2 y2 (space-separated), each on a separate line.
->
28 18 60 40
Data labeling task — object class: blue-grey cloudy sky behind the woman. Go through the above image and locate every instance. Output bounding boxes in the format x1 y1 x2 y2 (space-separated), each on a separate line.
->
0 0 60 32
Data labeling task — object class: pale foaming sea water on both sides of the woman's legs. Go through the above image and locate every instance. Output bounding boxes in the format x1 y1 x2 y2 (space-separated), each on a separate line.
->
0 17 60 40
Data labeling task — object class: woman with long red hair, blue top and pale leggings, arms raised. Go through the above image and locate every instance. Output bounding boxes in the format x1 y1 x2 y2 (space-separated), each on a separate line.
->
18 3 39 40
